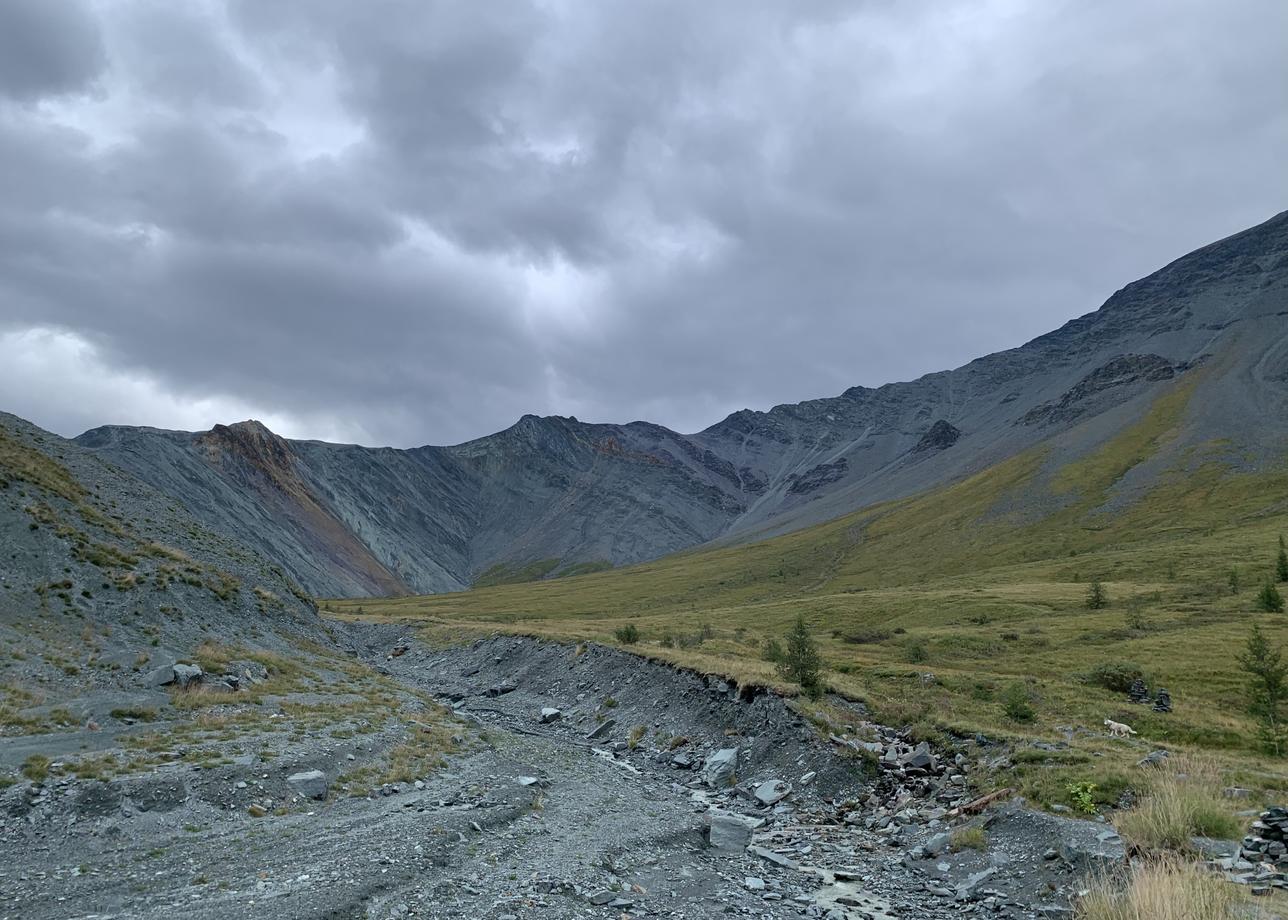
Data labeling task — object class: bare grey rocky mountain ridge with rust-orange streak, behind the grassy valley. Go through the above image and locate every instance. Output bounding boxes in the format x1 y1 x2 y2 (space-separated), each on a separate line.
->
77 213 1288 595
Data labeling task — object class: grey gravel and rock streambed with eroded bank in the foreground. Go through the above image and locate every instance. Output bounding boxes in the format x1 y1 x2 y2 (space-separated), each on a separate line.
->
0 628 1123 920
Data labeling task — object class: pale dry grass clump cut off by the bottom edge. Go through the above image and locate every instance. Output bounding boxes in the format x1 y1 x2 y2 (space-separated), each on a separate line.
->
1074 858 1248 920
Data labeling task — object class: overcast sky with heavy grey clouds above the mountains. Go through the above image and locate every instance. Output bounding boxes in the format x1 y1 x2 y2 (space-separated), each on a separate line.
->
0 0 1288 447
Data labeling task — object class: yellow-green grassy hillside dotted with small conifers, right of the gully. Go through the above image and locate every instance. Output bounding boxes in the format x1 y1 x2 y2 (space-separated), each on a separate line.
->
325 383 1288 804
